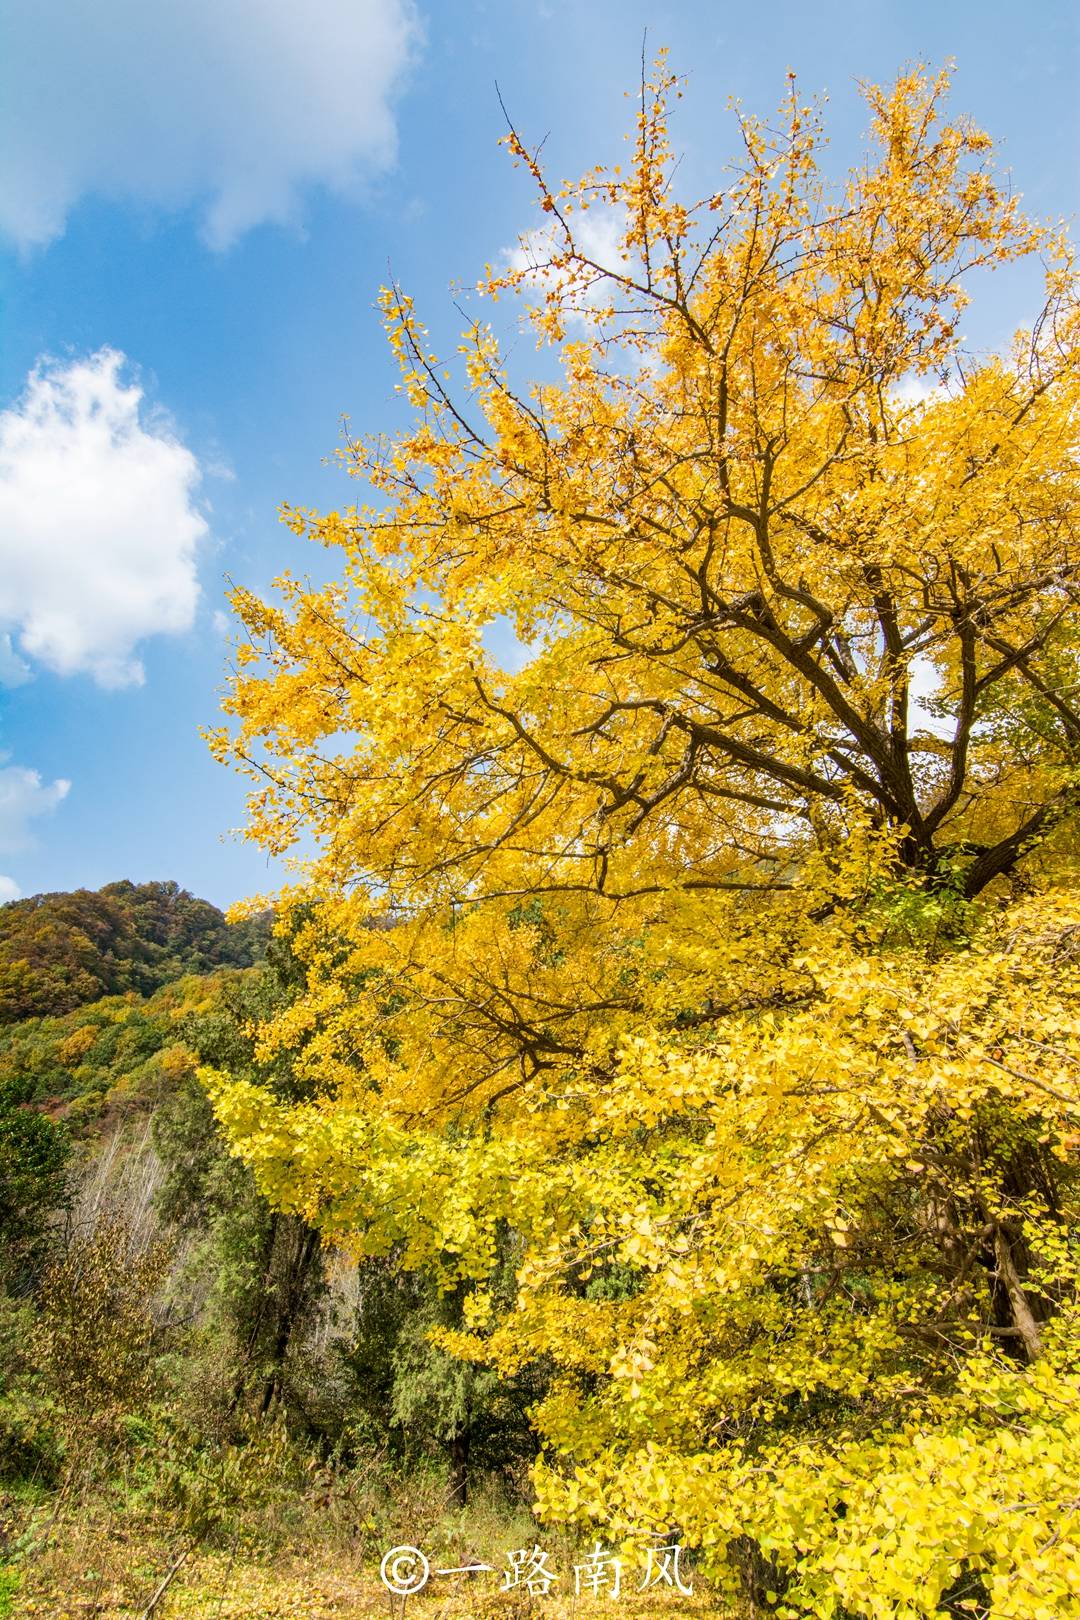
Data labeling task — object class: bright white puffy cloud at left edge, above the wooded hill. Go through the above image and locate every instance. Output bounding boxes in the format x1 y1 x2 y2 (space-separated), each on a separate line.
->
0 350 207 687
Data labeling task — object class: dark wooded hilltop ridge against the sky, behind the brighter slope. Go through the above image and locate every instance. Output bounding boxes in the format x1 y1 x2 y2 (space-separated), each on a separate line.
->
0 881 269 1024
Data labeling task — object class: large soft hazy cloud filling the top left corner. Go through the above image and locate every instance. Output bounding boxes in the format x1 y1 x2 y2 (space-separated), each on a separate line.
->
0 0 418 248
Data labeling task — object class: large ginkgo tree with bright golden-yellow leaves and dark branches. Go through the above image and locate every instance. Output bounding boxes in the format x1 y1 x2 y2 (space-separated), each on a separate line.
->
204 58 1080 1620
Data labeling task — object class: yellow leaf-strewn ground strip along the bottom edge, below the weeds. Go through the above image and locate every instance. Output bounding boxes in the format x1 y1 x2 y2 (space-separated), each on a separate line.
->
0 1483 744 1620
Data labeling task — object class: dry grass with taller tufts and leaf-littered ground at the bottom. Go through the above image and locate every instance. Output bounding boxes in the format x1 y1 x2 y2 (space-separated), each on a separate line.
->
0 1442 733 1620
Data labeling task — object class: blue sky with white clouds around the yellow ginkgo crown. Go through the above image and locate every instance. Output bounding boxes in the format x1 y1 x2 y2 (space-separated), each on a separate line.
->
0 0 1080 904
